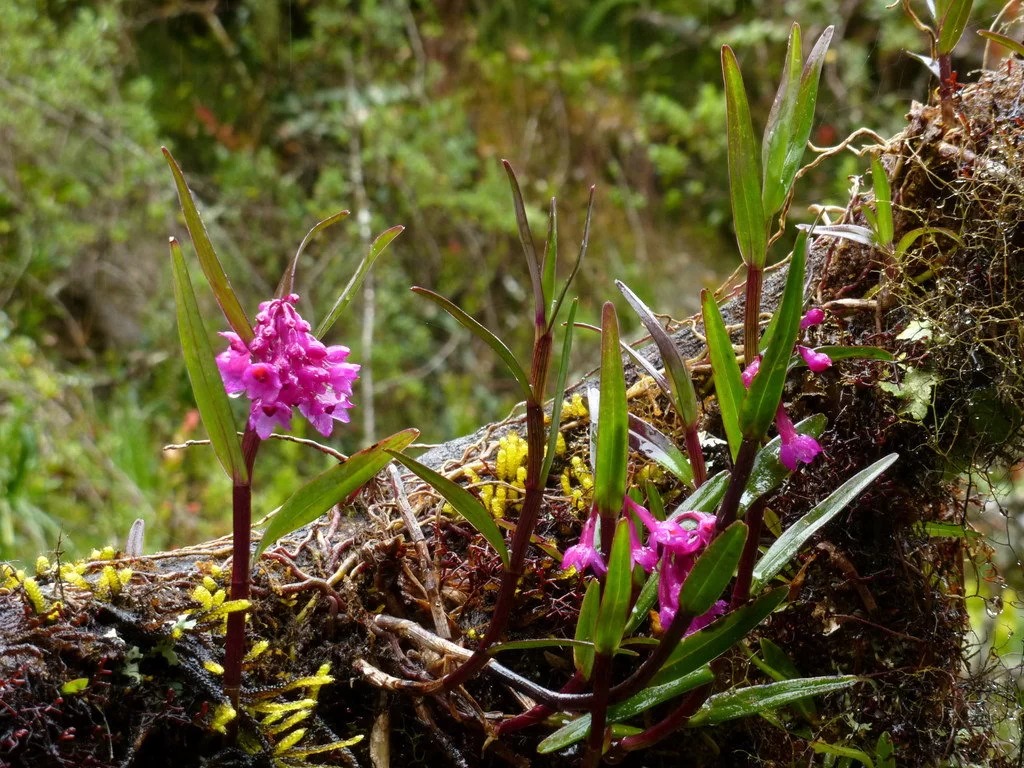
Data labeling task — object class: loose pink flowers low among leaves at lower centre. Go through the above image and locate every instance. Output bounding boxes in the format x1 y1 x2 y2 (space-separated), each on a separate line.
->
562 497 727 634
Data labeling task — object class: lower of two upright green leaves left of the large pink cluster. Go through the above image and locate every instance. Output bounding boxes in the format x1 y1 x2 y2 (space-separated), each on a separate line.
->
170 238 249 484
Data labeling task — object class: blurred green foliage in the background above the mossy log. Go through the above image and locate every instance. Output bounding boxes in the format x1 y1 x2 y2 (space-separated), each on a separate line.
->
0 0 999 558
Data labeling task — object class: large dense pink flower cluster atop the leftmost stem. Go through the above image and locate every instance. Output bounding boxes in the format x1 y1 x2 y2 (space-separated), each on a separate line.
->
217 293 359 440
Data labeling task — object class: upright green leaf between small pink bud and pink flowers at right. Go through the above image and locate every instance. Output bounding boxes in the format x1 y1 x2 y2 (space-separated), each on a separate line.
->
741 232 807 440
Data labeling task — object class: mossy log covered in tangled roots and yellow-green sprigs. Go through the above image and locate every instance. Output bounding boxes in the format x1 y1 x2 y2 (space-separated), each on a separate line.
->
6 63 1024 768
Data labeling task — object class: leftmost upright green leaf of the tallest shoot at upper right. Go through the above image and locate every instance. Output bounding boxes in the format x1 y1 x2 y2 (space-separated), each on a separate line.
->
722 45 768 269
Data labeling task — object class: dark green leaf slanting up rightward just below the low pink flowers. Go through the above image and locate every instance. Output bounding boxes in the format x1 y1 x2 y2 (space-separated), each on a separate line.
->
650 587 790 685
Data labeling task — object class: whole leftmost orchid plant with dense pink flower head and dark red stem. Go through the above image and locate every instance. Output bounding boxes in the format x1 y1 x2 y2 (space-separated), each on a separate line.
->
164 148 411 730
